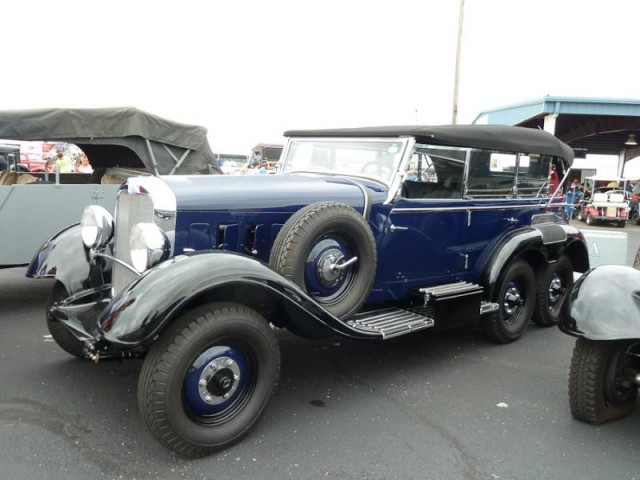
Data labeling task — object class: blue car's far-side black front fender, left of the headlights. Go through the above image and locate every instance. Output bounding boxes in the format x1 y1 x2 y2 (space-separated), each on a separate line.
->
26 224 111 295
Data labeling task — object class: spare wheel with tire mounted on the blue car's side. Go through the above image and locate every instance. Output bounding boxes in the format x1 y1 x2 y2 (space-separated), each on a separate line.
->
269 202 377 319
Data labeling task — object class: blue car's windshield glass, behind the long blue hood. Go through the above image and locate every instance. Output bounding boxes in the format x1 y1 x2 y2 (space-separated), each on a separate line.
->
282 139 405 185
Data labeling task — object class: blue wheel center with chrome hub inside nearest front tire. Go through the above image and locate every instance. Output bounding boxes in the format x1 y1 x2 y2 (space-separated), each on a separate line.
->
183 345 248 417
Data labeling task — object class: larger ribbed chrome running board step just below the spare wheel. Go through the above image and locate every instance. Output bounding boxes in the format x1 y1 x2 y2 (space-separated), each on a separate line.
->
347 307 434 340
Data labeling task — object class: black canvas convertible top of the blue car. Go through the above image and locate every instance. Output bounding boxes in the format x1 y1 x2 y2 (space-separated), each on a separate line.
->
284 125 574 164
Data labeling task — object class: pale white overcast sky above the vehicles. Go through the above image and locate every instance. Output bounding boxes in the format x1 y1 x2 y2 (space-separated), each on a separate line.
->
5 0 640 153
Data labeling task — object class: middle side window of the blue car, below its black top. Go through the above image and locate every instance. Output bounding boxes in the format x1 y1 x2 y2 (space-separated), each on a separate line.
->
467 149 518 198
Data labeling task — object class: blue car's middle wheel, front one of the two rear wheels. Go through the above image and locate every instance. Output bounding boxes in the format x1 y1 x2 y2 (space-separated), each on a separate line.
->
482 259 536 343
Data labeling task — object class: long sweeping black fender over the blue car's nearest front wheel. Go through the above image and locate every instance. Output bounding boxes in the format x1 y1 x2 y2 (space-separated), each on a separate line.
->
98 251 381 349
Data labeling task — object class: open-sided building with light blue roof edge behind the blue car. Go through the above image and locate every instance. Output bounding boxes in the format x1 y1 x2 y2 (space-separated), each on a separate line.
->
473 96 640 175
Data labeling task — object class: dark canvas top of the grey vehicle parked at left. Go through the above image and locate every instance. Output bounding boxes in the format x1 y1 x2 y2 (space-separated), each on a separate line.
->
0 107 221 175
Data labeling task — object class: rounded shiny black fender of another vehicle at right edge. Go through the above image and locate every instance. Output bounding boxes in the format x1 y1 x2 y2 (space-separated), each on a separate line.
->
558 265 640 340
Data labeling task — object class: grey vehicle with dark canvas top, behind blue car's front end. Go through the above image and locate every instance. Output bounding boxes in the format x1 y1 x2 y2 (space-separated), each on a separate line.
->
0 108 221 268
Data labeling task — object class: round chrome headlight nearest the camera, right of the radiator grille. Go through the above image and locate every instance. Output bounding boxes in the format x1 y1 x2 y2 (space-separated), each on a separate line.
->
129 223 171 273
